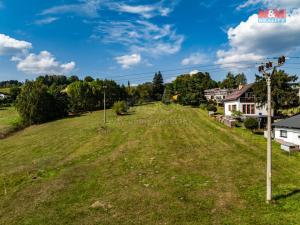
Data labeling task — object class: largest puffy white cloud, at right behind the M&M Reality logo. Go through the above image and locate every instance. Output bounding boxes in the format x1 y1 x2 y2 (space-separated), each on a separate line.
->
217 9 300 66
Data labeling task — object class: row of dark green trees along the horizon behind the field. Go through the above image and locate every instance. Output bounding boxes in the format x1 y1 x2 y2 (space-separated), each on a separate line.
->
1 71 299 125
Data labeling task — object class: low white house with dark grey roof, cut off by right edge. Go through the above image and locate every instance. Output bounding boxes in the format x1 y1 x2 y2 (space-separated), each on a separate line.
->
273 114 300 151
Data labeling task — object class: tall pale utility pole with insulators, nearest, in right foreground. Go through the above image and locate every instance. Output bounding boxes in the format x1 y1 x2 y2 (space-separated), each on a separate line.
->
258 56 285 204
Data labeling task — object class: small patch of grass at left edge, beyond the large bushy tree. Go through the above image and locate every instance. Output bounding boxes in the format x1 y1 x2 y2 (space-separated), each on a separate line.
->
0 107 19 133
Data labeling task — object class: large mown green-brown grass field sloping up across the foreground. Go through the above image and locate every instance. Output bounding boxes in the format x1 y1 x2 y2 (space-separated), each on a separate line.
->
0 104 300 225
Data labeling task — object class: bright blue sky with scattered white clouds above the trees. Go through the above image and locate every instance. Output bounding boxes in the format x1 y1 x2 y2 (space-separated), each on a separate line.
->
0 0 300 83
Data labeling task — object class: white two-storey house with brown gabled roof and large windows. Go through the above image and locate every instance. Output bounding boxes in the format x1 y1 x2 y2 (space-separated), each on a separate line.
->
223 84 267 117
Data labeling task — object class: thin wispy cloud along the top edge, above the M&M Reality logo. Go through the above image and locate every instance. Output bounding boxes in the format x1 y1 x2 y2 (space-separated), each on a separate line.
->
237 0 300 10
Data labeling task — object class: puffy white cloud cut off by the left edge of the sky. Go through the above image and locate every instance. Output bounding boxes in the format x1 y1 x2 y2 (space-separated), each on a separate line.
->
0 34 32 55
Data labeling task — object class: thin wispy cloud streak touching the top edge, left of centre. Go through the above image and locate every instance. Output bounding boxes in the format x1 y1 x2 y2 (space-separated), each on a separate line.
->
40 0 102 17
